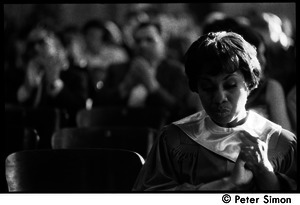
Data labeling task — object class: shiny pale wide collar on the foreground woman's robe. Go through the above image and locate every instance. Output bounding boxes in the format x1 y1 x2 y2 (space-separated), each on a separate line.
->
173 110 282 162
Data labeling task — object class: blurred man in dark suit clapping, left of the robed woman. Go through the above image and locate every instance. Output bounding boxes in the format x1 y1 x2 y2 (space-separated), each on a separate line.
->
93 21 196 119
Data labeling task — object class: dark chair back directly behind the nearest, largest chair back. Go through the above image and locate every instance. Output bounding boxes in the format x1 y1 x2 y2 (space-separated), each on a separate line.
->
51 127 157 158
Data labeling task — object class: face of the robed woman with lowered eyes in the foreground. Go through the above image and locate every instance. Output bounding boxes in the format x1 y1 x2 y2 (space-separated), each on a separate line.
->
197 71 249 127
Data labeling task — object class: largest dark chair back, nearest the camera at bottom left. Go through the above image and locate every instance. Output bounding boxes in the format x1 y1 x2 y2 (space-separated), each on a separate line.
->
6 149 144 193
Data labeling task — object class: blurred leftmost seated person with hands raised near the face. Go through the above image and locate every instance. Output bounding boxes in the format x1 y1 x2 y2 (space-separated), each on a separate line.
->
17 27 88 121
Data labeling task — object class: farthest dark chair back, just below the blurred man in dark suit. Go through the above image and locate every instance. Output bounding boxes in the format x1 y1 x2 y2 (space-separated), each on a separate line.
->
76 106 168 129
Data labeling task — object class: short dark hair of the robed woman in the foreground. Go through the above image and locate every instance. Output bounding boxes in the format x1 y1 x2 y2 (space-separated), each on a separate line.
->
185 31 261 92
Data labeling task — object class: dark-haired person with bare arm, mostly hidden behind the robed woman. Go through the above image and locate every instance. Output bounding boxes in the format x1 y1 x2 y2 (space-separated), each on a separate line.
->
203 17 291 131
